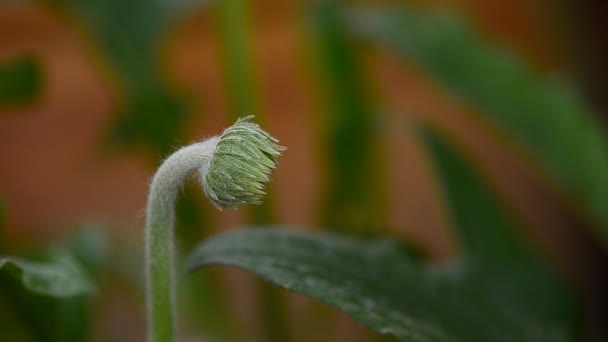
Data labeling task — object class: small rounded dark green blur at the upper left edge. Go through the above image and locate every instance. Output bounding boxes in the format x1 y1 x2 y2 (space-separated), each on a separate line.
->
0 56 42 105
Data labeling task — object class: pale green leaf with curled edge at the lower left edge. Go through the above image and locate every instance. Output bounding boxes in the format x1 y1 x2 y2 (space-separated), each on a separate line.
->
0 254 94 297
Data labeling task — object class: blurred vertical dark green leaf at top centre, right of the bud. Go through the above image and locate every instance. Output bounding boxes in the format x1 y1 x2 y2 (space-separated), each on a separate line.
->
310 0 385 234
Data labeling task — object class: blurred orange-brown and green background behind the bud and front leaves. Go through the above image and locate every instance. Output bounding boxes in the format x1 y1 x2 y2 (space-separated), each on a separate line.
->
0 0 608 341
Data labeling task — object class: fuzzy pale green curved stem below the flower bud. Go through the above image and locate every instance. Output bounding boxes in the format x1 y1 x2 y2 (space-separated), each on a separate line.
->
145 137 219 342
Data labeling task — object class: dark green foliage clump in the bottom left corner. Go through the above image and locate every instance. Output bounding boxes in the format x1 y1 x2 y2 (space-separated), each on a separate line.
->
0 253 94 342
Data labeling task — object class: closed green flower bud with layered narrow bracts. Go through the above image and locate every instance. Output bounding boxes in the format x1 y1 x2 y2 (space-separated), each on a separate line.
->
201 116 285 209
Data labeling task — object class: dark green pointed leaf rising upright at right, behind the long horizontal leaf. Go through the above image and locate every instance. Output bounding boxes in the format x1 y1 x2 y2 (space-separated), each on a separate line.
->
420 127 578 328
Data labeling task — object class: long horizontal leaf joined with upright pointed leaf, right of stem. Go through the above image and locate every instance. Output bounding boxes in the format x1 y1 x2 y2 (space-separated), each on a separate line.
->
187 130 579 341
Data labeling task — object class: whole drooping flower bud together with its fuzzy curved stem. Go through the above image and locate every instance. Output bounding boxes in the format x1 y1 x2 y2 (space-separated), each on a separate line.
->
145 116 285 342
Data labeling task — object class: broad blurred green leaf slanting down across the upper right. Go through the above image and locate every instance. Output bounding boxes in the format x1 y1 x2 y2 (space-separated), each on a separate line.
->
349 6 608 246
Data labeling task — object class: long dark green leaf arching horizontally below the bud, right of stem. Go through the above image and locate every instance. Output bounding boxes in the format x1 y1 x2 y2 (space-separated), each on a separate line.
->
187 228 573 341
